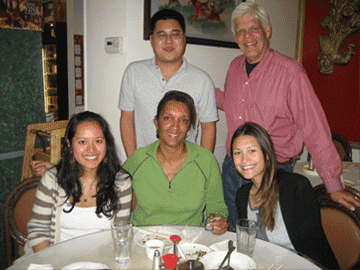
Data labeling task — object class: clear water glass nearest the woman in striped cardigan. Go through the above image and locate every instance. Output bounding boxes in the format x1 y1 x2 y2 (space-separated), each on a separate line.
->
111 222 132 265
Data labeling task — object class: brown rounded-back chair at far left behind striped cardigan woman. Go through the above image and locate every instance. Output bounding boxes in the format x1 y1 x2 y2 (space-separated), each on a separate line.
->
3 178 40 267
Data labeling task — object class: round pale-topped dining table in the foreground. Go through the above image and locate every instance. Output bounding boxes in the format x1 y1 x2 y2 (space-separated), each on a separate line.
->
8 225 321 270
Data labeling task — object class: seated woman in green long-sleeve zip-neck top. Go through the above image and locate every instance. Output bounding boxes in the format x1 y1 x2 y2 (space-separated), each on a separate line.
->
123 91 228 234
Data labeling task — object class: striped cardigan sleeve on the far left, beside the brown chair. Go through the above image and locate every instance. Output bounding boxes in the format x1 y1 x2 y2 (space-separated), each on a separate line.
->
27 170 59 247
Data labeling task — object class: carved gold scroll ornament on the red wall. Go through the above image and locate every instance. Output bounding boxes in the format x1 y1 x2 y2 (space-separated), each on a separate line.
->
317 0 360 75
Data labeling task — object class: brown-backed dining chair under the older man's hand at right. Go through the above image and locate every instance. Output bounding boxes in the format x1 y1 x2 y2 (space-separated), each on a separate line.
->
314 184 360 270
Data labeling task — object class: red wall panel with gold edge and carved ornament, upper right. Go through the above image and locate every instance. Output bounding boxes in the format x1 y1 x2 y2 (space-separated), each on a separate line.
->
296 0 360 146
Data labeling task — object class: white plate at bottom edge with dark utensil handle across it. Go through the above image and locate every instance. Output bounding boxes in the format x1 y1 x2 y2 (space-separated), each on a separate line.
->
200 251 256 270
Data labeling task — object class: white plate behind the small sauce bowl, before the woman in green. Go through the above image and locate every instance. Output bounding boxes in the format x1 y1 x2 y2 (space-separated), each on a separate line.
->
134 226 181 248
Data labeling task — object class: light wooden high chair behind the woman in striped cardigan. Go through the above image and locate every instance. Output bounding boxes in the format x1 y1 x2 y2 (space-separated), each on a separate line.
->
21 120 69 181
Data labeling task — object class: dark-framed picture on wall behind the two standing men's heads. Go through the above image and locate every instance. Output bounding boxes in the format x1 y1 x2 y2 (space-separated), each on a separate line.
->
144 0 246 48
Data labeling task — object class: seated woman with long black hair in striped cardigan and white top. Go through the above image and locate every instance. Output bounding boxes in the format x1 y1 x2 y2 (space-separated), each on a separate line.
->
25 111 132 252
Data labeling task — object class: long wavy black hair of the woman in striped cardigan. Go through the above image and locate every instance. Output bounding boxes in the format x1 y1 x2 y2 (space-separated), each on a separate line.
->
56 111 121 218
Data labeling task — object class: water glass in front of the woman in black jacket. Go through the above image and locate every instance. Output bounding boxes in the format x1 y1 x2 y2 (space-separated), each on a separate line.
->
236 219 258 257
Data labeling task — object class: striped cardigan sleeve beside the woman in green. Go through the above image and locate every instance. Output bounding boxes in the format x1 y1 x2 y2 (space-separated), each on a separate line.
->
115 169 132 221
